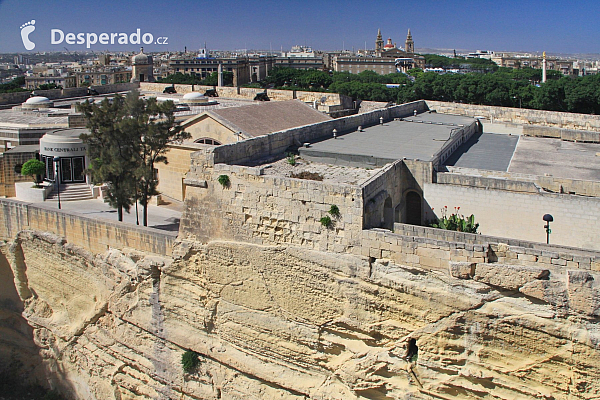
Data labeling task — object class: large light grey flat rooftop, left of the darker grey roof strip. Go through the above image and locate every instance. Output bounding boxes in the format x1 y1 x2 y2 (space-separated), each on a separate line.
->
300 113 475 165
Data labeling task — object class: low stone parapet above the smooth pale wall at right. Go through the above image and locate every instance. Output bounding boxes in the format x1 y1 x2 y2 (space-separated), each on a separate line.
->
437 166 600 197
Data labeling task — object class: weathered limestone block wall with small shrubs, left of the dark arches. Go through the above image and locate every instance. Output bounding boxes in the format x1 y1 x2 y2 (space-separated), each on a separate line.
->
180 160 363 253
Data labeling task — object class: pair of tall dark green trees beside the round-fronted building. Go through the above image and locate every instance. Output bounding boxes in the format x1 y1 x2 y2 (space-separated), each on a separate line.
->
79 91 190 226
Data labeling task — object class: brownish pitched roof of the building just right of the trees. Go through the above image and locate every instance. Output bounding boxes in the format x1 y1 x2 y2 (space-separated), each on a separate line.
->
198 100 332 137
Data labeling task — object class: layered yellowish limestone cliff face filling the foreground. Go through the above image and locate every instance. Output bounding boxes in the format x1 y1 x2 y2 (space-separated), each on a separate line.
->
0 232 600 399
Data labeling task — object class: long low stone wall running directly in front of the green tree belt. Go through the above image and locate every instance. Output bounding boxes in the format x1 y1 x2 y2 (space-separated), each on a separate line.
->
427 100 600 131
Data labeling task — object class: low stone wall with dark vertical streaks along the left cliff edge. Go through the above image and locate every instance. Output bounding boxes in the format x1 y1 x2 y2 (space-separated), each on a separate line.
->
0 199 177 255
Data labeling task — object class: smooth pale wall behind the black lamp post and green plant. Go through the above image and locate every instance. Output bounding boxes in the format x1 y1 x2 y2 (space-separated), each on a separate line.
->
423 184 600 250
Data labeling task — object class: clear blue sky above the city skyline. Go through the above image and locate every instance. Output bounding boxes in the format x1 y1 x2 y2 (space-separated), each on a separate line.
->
0 0 600 53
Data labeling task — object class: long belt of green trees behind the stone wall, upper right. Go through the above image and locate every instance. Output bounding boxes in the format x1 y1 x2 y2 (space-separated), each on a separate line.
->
250 64 600 114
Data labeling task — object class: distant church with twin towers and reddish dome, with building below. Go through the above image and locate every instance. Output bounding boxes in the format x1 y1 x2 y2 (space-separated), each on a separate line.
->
332 29 425 75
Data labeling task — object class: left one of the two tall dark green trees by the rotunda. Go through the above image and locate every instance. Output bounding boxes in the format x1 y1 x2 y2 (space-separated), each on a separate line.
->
79 95 137 221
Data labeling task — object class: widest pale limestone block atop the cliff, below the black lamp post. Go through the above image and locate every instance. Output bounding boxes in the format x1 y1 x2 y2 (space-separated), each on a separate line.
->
473 263 550 290
